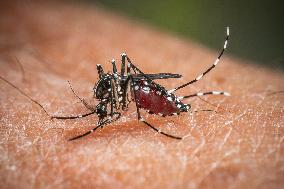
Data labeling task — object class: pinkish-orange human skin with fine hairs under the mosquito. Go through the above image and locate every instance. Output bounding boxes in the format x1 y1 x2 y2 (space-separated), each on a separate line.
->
0 3 284 188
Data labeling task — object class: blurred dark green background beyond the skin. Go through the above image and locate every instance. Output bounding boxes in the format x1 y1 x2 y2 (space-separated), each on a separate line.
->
90 0 284 70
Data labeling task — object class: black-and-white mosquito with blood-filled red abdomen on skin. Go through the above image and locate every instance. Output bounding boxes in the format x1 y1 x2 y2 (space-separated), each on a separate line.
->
0 27 230 141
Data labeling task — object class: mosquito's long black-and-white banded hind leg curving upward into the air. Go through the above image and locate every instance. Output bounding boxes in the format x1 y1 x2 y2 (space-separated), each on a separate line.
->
168 27 229 93
